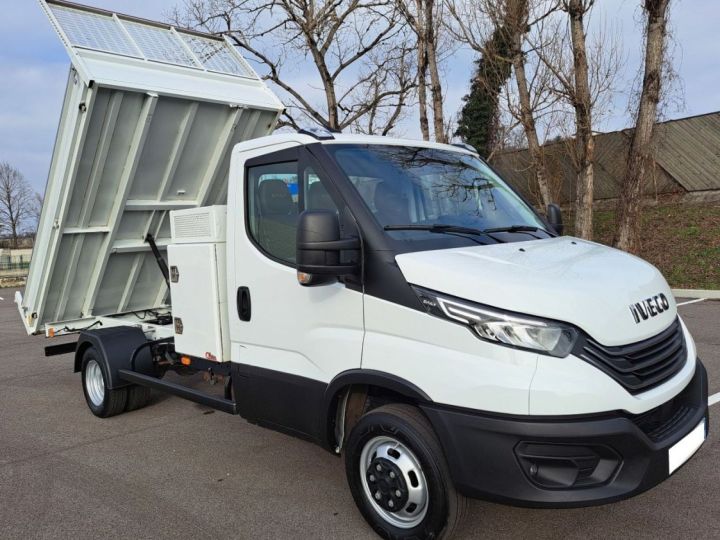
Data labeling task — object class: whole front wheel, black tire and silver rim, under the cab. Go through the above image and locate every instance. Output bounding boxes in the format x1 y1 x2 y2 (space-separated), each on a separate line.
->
345 404 466 539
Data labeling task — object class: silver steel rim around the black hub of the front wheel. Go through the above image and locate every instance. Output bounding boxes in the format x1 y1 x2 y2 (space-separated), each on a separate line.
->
360 436 428 529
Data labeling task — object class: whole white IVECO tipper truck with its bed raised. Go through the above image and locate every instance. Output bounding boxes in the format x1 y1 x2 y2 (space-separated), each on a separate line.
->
16 0 708 538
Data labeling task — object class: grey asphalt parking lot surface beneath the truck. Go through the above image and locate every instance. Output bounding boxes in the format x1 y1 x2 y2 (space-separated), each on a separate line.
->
0 289 720 539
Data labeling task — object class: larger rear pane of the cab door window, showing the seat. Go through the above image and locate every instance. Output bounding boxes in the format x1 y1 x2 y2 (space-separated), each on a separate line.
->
246 161 300 263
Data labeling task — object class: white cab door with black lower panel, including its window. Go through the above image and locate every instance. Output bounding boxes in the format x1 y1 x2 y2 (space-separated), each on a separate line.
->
228 147 364 438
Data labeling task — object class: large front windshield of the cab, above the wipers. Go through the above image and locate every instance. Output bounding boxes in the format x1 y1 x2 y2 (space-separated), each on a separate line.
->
325 144 545 238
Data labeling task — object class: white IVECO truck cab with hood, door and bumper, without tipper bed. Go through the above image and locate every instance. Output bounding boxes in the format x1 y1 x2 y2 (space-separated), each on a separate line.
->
170 130 707 535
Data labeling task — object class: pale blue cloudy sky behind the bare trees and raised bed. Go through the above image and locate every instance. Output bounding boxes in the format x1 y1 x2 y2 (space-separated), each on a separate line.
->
0 0 720 192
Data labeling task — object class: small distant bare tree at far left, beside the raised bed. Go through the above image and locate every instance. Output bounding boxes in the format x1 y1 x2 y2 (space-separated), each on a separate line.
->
0 162 33 248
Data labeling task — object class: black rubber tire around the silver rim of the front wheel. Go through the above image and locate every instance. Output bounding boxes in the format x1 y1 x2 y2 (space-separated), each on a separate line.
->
345 404 467 539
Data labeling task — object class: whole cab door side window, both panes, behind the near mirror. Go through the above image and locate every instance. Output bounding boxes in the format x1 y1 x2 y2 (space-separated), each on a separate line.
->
246 161 338 264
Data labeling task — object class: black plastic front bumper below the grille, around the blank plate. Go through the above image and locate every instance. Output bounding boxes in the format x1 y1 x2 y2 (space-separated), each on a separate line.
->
423 360 708 507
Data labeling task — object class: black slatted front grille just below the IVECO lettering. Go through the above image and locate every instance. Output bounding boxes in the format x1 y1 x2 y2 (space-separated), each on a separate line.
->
576 318 687 394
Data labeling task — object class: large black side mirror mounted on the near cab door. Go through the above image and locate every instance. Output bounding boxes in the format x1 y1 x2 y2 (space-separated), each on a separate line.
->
296 210 360 286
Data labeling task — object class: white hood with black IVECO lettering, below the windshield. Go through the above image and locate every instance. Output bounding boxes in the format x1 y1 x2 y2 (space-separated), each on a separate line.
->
396 236 677 345
